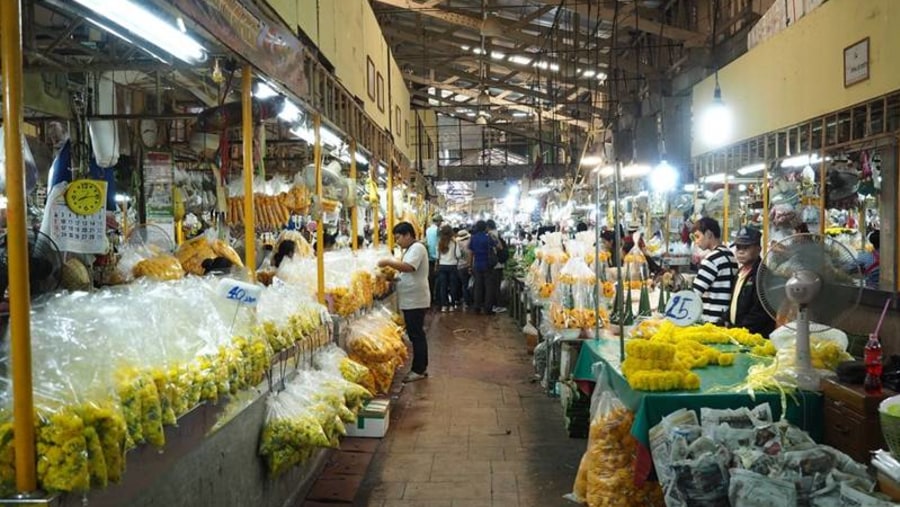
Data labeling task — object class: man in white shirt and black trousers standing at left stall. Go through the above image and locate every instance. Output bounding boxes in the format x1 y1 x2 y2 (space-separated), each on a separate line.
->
378 222 431 382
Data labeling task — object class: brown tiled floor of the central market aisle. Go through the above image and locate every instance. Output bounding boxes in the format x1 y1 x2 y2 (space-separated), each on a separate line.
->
305 313 586 507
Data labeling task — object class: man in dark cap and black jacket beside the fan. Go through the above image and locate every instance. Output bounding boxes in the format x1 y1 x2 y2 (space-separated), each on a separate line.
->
728 227 775 338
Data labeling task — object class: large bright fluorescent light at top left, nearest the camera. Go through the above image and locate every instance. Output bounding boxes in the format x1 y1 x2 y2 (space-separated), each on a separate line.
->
75 0 206 63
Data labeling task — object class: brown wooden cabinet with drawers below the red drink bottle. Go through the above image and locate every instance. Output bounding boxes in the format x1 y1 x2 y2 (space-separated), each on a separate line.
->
822 379 894 464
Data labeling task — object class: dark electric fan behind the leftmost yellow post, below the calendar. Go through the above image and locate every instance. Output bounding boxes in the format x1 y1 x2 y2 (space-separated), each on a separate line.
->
0 230 63 299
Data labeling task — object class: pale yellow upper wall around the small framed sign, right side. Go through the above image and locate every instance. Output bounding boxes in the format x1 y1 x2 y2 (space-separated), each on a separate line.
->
691 0 900 156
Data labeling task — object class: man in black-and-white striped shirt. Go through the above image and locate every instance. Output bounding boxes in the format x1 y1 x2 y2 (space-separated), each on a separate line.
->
693 217 738 324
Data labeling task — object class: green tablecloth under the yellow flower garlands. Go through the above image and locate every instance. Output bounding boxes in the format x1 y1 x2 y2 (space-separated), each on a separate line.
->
573 339 824 446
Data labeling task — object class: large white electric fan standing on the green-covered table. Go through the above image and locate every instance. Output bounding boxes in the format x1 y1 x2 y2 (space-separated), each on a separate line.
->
756 234 863 390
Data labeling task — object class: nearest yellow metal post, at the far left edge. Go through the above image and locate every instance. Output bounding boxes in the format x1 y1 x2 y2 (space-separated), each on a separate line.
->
0 0 37 493
